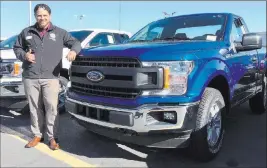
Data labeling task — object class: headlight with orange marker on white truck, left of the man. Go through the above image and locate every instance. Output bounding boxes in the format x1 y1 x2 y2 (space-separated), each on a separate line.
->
0 61 22 77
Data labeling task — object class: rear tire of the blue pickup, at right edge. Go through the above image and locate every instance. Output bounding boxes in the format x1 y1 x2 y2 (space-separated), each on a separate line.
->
249 75 267 114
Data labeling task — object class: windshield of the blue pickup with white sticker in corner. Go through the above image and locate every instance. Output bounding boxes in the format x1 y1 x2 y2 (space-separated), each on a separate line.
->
128 14 225 42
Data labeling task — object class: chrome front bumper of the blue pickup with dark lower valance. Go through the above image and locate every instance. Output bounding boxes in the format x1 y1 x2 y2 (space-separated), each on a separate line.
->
65 97 199 148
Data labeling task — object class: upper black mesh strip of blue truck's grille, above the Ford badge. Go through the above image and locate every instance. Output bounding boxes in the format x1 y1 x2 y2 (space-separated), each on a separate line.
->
72 56 141 68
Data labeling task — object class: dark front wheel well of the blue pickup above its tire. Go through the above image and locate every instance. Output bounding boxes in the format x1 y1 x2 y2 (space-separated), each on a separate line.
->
208 75 230 114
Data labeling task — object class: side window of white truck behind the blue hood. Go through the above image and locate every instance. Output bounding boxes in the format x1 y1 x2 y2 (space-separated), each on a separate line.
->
89 33 114 46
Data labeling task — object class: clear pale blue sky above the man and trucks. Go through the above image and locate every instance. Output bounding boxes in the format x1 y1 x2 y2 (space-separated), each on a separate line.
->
0 1 266 37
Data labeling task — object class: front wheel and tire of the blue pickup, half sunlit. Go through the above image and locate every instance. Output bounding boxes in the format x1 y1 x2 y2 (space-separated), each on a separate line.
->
189 88 225 162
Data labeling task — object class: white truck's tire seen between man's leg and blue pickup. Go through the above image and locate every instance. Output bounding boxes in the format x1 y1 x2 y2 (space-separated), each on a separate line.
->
58 76 68 113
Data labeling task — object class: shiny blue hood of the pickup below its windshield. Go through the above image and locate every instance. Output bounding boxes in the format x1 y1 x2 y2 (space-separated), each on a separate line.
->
80 41 224 60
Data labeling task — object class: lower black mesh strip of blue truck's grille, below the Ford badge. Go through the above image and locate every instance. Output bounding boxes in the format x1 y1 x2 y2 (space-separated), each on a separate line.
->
71 82 141 99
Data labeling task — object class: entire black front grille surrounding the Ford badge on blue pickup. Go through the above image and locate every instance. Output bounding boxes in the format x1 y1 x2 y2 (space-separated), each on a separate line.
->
71 56 141 99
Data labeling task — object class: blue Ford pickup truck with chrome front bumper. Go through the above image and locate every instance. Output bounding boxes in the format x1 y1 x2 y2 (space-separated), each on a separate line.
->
65 13 267 161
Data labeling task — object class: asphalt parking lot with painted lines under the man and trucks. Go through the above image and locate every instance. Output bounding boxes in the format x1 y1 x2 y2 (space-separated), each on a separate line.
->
0 100 266 167
